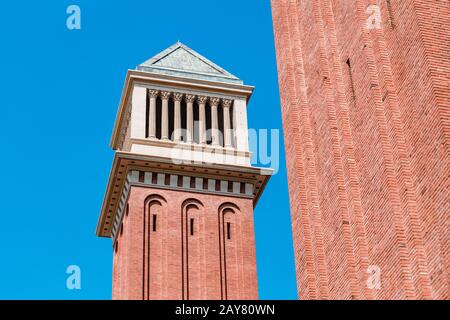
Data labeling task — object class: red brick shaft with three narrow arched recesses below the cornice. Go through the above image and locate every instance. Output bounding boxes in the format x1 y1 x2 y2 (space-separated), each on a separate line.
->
113 186 258 300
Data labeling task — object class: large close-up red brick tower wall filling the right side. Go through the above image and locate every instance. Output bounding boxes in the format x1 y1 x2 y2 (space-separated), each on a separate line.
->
271 0 450 299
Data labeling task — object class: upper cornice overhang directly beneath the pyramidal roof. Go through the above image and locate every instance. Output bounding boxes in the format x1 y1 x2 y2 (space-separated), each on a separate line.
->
110 70 254 150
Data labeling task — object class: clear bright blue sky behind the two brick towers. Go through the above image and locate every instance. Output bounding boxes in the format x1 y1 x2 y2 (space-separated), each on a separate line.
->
0 0 297 299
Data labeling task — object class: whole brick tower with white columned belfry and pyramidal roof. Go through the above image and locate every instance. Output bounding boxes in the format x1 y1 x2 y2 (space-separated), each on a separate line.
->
97 43 270 300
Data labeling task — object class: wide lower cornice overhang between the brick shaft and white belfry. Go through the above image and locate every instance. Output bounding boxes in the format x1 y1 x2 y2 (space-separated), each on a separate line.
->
96 151 273 237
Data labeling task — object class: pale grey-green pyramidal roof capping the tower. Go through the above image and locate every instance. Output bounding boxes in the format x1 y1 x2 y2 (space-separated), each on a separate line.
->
137 42 243 84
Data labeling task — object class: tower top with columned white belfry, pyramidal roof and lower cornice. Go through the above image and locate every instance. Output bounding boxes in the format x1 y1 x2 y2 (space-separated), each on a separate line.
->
97 42 271 238
